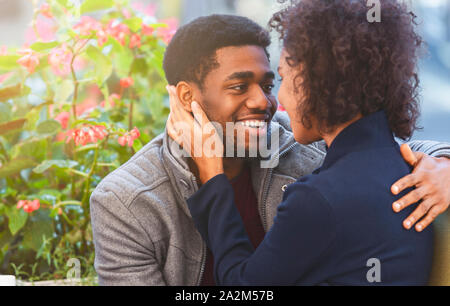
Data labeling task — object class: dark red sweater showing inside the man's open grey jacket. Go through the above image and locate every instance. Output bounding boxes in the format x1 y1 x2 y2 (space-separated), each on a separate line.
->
200 167 265 286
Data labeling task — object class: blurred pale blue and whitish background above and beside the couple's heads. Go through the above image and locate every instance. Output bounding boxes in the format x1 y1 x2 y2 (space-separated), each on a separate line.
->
0 0 450 142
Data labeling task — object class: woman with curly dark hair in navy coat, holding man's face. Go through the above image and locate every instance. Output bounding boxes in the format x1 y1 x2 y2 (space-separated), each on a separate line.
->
168 0 433 285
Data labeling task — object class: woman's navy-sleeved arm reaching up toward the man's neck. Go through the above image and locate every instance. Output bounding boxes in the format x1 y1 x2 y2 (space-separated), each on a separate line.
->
187 174 336 285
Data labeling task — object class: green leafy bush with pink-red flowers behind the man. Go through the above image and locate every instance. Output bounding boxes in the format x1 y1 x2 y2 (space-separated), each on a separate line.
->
0 0 177 280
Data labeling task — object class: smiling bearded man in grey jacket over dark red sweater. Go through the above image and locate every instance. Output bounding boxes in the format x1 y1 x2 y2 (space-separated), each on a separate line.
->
91 15 450 285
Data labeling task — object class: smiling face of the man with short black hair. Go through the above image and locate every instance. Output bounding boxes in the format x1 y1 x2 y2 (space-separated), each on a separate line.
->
193 46 278 155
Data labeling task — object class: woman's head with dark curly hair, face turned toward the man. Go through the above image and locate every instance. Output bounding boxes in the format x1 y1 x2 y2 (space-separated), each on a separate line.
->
270 0 422 143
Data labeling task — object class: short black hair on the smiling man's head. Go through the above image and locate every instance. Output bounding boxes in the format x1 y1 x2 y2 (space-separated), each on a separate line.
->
163 15 270 88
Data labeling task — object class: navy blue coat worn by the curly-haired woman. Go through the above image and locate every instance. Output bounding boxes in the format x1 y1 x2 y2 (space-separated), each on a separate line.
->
188 111 433 285
